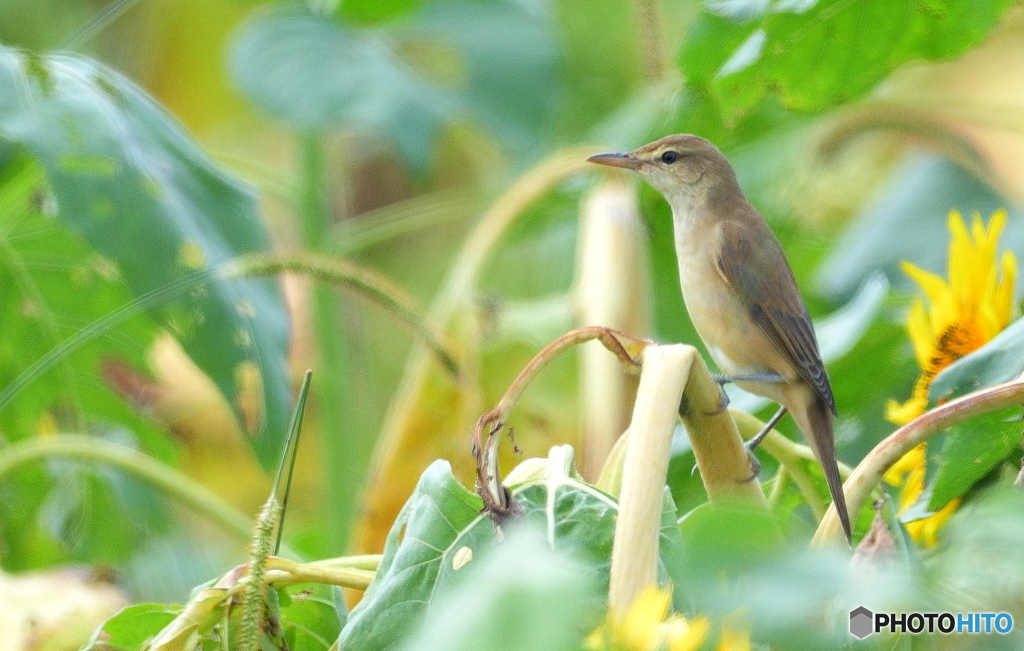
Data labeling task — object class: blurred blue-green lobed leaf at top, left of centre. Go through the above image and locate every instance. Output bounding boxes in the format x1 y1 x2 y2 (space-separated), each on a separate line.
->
230 2 555 168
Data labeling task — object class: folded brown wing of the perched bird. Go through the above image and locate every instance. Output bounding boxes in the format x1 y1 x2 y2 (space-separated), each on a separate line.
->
718 215 836 414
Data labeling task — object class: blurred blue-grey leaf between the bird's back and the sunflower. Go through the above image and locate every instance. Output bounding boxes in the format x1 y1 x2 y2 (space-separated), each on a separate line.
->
816 156 1024 296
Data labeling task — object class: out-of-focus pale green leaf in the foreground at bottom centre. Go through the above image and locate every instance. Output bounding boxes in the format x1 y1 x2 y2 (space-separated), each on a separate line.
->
393 523 601 651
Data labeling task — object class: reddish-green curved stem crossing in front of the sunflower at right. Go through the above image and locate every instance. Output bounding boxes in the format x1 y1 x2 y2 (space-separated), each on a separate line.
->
812 380 1024 546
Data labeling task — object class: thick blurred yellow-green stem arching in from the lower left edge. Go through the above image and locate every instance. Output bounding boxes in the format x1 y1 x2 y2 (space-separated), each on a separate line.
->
0 434 252 540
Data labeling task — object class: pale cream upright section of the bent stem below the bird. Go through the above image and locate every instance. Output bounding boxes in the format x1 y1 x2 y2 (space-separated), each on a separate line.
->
608 344 696 614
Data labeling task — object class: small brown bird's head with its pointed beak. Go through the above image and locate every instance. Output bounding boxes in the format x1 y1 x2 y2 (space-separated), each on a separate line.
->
587 133 736 202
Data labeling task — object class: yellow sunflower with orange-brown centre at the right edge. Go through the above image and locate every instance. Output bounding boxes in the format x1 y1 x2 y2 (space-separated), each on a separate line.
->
885 210 1017 547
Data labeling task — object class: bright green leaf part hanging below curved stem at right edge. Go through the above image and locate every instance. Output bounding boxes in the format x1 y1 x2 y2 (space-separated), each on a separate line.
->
928 406 1024 511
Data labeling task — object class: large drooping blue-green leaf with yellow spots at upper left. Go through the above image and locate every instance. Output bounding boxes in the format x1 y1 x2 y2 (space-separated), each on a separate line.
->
0 48 291 465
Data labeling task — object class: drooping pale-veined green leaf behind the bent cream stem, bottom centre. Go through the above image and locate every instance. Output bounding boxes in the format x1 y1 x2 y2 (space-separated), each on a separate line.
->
339 446 681 651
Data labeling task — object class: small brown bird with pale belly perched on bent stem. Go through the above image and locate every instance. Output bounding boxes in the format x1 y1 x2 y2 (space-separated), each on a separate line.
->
587 134 852 543
